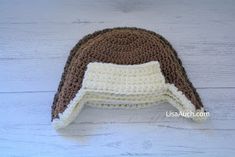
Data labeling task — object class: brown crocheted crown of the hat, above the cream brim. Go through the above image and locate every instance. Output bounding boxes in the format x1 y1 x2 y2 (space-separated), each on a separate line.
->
52 27 203 120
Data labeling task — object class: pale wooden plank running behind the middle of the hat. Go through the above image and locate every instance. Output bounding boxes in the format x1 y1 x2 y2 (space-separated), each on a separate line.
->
0 55 235 92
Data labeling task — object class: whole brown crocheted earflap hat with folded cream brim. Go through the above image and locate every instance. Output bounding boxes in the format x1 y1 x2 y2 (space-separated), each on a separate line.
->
52 27 204 129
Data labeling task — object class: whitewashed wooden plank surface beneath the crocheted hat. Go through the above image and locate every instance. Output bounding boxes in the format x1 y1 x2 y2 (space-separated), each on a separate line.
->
0 0 235 157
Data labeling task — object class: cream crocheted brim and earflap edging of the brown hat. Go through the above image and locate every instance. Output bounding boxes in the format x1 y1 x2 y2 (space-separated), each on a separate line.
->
52 61 204 129
